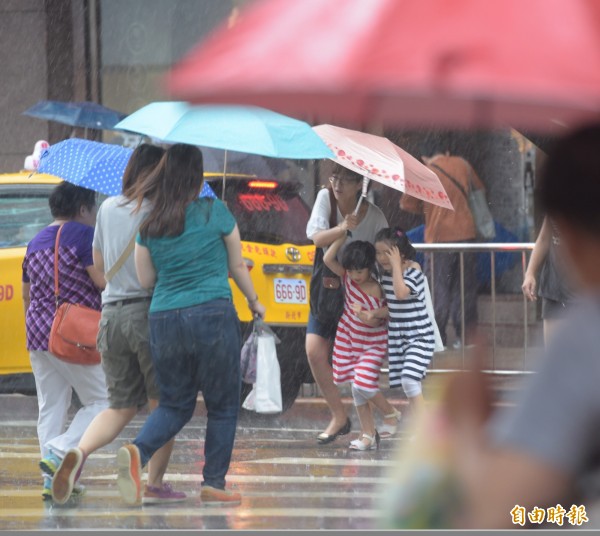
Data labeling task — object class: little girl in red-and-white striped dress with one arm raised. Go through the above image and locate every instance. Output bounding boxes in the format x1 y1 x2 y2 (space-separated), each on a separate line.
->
323 236 387 450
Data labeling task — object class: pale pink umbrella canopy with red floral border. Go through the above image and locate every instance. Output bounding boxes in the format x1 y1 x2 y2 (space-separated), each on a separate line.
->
313 125 452 209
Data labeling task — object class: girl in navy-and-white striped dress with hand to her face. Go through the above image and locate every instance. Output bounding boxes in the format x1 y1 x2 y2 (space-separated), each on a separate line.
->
375 227 435 411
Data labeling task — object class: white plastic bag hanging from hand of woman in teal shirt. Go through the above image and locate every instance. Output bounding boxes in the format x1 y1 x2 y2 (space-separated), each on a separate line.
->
242 330 283 413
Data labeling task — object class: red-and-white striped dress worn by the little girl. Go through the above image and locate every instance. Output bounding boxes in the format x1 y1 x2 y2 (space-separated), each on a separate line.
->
333 275 387 392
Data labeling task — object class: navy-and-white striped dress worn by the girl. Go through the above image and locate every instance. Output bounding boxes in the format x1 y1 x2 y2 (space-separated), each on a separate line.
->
381 268 435 387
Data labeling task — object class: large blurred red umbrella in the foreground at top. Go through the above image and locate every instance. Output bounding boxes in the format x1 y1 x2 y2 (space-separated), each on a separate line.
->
168 0 600 132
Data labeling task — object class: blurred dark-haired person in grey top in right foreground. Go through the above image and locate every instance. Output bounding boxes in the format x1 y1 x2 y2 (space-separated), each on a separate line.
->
384 125 600 529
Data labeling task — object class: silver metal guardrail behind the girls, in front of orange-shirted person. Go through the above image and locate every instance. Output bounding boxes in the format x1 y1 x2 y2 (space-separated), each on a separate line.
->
404 242 534 375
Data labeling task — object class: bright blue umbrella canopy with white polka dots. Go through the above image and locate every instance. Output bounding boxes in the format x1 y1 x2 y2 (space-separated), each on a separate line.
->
37 138 216 197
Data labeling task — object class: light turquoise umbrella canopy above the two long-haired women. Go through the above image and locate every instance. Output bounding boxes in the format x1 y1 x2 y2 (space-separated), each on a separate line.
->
115 102 333 159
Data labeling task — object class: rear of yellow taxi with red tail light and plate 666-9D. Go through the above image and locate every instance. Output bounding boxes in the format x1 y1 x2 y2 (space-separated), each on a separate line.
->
205 173 315 411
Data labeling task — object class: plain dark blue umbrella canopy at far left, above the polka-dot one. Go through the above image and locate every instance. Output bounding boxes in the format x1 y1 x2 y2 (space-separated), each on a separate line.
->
23 101 126 130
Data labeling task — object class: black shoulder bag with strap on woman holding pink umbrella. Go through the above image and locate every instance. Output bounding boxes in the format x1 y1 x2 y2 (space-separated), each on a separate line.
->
310 186 344 324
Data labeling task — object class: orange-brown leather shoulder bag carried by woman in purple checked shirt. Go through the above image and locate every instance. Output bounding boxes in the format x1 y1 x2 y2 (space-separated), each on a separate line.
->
48 225 101 365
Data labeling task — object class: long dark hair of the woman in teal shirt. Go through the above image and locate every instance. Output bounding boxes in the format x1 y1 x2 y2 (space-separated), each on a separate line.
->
135 143 204 238
